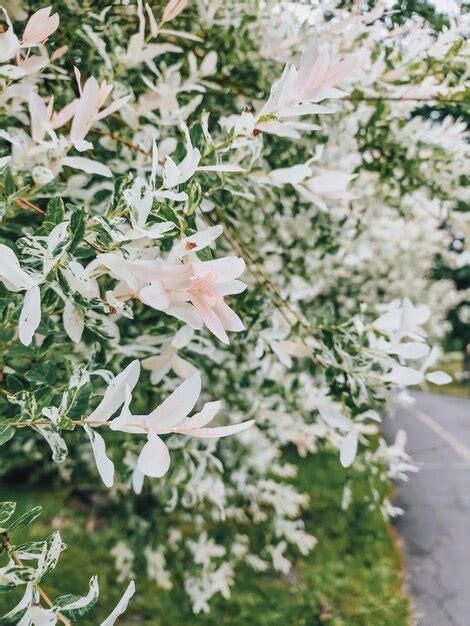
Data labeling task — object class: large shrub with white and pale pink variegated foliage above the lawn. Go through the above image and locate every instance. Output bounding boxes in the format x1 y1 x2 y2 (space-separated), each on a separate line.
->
0 0 468 624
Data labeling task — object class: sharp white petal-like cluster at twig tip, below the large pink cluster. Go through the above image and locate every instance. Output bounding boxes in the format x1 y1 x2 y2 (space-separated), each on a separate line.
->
111 374 254 478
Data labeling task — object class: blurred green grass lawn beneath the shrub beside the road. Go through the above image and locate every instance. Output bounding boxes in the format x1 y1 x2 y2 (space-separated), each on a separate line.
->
0 453 409 626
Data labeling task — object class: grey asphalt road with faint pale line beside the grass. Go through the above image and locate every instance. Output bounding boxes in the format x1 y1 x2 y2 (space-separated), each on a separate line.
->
384 393 470 626
